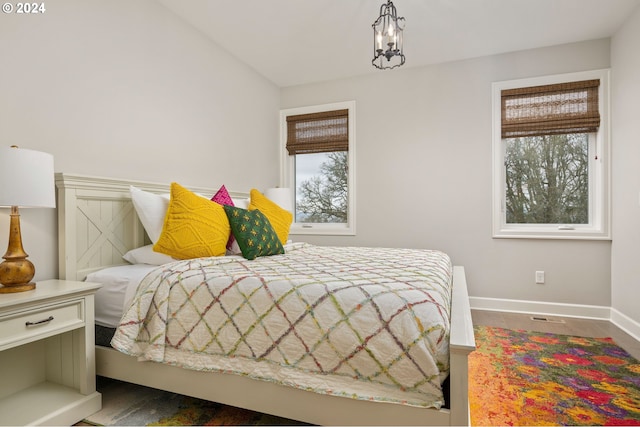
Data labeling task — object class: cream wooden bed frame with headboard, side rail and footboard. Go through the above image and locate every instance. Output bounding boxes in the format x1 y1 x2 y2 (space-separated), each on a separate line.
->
56 173 475 425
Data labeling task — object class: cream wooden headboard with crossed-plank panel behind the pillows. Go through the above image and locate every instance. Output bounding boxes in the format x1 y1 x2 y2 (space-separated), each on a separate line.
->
56 173 248 280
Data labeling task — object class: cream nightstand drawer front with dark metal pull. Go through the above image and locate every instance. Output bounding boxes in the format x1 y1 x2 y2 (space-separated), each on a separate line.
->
0 299 84 349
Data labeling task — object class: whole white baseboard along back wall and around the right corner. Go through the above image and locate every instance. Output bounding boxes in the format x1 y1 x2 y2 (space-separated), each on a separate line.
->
469 297 640 341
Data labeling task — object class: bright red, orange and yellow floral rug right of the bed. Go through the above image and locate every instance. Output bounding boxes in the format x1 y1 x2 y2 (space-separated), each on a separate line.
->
469 326 640 426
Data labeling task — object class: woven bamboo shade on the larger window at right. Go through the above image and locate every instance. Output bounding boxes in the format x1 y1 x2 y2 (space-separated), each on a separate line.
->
502 80 600 138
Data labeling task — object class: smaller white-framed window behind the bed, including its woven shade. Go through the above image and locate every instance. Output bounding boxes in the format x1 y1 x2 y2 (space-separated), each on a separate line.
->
280 102 355 234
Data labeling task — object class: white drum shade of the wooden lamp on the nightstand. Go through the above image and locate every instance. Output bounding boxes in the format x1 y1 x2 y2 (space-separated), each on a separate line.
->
0 147 56 208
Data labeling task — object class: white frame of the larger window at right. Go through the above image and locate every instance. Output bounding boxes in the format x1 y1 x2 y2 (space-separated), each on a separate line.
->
492 69 611 240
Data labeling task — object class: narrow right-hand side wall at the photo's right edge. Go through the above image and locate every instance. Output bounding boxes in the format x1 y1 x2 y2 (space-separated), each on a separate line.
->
611 8 640 323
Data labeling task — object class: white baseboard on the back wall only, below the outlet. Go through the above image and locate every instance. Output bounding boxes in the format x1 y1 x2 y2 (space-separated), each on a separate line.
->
469 297 611 320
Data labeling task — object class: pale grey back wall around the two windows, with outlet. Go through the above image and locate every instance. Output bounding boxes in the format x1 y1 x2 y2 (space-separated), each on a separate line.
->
282 39 608 306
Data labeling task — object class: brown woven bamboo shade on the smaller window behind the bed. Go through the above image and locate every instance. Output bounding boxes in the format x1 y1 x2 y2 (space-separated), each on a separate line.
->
287 109 349 156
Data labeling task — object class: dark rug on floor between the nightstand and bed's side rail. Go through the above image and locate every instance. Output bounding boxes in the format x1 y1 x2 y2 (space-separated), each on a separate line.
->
82 377 304 426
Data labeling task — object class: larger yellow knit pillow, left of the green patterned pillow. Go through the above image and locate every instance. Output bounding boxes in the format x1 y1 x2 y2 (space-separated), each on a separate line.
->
153 182 231 259
